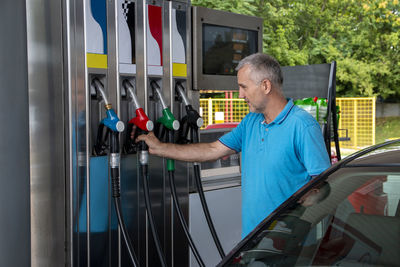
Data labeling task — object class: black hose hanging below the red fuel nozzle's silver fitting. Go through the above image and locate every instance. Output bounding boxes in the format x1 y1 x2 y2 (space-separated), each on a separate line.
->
140 164 167 267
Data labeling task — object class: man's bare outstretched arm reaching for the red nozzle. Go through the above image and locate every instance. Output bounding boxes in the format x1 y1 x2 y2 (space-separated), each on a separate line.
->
136 132 236 162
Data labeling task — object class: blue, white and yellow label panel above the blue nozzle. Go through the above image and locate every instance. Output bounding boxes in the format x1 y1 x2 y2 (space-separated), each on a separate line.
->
85 0 107 68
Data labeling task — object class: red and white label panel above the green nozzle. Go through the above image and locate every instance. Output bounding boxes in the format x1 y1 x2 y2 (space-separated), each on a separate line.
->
146 5 163 75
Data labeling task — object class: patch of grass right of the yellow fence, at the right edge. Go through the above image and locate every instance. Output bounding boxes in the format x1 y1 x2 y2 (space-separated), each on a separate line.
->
375 117 400 144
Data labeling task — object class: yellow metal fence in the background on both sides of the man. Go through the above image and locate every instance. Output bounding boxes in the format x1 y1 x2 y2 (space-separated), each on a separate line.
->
200 97 376 149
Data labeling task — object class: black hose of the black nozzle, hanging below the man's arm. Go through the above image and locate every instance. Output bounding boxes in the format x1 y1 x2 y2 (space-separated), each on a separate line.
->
194 164 225 258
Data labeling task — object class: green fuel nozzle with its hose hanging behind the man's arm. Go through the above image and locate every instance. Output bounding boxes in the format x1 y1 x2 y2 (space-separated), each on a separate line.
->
150 81 205 267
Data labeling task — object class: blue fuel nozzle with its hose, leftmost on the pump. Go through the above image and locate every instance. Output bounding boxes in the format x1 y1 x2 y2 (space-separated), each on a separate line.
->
91 78 139 267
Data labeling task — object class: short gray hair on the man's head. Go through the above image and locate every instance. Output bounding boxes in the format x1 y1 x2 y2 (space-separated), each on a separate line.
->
236 53 283 89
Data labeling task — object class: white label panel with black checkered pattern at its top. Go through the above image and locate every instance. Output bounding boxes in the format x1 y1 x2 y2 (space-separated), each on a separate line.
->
118 0 136 74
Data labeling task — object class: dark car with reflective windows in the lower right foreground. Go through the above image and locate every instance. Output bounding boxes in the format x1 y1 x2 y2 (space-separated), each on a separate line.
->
217 139 400 267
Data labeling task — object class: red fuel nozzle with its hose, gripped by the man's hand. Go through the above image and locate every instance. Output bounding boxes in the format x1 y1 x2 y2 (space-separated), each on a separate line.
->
122 80 167 266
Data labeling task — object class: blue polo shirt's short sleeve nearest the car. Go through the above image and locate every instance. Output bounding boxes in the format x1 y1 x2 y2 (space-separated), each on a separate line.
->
299 123 331 176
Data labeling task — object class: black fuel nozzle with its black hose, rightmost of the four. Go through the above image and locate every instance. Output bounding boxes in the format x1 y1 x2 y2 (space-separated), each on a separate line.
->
175 82 225 258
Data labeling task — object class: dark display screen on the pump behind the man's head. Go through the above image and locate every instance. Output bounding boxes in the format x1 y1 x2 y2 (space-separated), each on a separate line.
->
203 24 258 76
